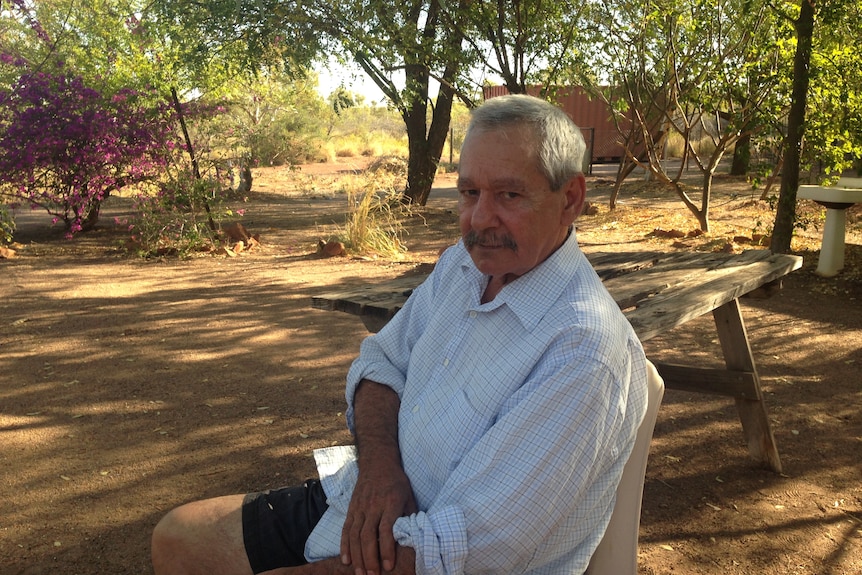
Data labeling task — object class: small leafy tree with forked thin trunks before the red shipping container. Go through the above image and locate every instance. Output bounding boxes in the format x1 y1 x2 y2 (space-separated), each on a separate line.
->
585 0 779 231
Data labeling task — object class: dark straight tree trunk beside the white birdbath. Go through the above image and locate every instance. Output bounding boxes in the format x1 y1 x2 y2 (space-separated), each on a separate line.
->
769 0 814 254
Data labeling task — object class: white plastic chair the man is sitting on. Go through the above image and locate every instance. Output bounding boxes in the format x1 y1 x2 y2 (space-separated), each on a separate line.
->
587 361 664 575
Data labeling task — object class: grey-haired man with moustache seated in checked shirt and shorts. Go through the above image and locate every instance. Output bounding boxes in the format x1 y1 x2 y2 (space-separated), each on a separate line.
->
153 96 646 575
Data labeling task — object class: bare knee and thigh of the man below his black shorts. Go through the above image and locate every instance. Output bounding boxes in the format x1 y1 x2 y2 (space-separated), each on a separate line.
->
152 495 251 575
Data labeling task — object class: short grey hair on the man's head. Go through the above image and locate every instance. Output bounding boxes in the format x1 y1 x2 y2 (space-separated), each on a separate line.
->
467 94 587 191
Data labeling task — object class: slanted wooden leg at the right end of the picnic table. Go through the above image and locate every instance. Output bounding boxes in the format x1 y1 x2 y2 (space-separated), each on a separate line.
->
712 299 781 473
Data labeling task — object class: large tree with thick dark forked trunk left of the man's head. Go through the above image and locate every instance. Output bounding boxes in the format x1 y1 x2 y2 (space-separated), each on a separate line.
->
152 0 476 204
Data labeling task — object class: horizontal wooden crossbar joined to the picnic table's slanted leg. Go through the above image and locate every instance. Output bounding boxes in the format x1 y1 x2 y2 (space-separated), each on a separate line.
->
653 361 760 399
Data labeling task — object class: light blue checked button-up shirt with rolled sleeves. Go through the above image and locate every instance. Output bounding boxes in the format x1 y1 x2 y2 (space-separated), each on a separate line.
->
306 233 646 575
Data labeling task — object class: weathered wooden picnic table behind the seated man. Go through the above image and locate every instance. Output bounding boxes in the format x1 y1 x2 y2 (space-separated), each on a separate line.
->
312 250 802 473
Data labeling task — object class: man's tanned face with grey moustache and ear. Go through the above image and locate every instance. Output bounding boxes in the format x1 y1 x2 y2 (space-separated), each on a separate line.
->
458 127 585 283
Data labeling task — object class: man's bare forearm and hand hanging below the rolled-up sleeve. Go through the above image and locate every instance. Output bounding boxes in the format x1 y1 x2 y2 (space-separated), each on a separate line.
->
341 380 417 575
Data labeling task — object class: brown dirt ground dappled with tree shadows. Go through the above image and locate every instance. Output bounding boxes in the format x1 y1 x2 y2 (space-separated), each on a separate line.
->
0 160 862 575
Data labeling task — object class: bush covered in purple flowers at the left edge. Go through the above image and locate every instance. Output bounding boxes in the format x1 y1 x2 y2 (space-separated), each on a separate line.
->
0 68 174 237
